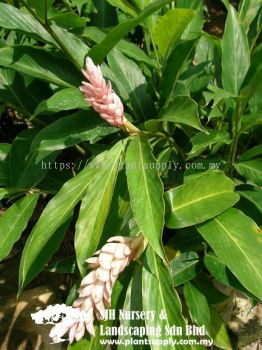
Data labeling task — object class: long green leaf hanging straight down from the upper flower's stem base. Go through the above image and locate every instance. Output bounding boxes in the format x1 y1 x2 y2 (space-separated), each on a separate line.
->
126 135 164 259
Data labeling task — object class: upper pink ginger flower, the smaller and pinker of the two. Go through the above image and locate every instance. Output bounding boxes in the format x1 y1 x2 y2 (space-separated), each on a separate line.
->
80 57 127 127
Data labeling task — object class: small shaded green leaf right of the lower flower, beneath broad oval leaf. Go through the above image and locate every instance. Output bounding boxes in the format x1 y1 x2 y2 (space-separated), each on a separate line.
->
170 252 199 287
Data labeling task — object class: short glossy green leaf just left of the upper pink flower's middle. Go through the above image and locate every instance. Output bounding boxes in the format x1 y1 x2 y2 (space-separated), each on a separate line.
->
34 88 89 116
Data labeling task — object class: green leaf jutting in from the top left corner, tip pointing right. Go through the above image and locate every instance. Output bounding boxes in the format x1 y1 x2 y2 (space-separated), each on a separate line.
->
0 3 55 44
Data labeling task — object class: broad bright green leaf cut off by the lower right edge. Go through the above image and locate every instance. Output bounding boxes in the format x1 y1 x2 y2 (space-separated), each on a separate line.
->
197 208 262 299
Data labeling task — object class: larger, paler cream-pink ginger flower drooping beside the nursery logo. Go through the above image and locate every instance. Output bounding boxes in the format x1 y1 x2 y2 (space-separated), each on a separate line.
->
49 235 143 343
